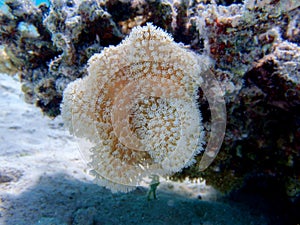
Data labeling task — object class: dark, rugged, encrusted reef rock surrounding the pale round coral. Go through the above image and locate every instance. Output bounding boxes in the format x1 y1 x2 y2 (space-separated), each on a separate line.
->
0 0 300 211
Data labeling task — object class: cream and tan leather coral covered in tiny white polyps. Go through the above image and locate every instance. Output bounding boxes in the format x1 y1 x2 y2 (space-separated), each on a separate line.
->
62 24 225 192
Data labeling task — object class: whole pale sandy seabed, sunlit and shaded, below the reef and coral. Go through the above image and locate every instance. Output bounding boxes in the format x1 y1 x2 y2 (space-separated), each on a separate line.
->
0 74 268 225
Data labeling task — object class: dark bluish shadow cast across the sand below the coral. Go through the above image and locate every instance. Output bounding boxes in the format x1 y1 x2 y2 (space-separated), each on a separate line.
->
0 174 276 225
